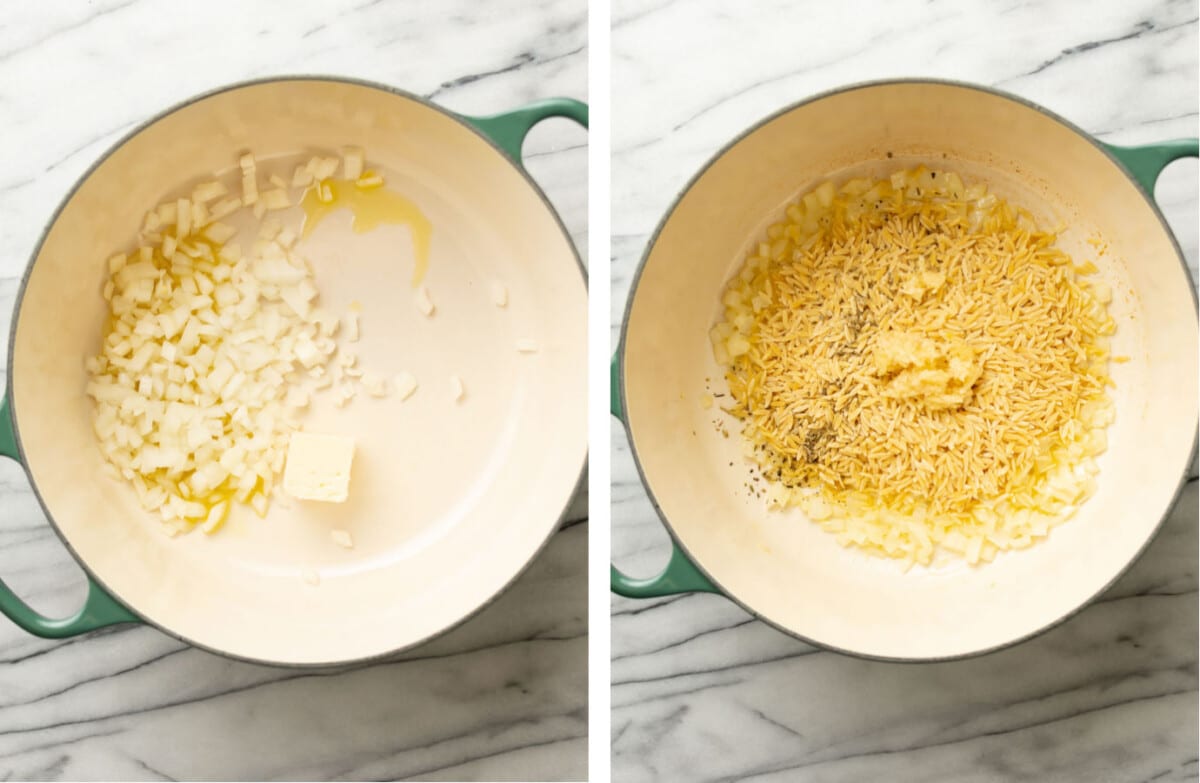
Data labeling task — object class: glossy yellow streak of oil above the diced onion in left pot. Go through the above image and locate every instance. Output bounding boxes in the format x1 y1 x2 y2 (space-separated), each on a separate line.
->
300 179 433 286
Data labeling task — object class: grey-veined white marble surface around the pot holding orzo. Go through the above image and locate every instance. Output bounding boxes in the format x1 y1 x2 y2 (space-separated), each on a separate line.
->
612 0 1198 783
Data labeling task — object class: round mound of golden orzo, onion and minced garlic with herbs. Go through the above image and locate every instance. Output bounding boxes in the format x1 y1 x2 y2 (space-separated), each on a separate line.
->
710 167 1116 564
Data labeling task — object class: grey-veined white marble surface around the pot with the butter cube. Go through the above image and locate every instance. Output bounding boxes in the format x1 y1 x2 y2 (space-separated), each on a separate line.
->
0 0 587 779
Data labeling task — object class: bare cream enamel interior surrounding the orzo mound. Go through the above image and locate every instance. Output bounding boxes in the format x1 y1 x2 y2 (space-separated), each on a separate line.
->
622 83 1198 659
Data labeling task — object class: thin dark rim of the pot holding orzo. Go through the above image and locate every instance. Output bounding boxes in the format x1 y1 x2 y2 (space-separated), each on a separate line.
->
617 77 1200 663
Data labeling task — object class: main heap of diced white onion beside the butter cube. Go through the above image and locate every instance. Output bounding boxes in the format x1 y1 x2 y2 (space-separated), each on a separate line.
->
86 155 353 534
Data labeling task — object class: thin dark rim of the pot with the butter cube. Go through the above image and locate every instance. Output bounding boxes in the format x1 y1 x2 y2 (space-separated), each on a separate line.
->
5 73 588 670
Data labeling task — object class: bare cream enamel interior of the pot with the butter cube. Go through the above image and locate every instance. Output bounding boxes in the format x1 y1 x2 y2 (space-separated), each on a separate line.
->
11 79 587 664
